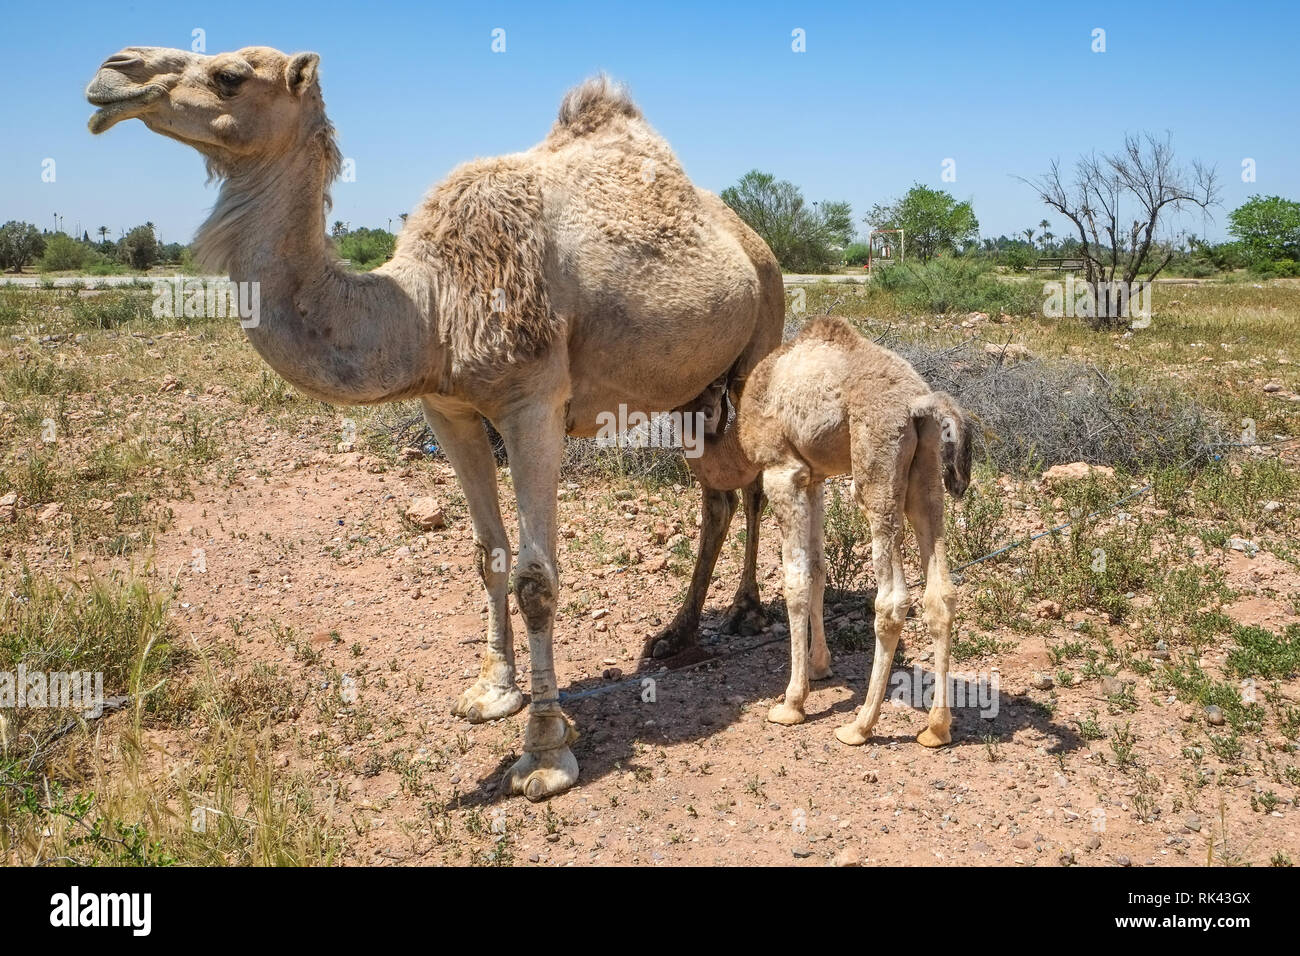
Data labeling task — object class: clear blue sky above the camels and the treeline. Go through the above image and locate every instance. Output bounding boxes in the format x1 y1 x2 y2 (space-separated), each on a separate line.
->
0 0 1300 248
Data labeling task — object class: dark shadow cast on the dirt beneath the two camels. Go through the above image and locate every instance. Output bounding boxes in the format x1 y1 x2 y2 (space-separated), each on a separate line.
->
460 598 1086 805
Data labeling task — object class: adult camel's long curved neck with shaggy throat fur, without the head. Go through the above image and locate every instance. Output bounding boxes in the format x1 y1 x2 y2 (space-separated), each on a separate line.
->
195 111 439 405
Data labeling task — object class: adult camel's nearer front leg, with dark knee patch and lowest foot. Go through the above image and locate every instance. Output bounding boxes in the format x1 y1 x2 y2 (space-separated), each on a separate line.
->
495 405 577 800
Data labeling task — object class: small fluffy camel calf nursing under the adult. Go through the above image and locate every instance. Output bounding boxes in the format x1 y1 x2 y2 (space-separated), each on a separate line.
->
738 317 974 747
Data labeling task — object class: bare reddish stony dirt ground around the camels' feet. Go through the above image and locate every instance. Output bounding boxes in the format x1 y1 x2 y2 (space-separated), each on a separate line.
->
137 434 1300 866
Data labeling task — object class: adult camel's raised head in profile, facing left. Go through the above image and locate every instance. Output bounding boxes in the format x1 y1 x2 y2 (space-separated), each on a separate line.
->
86 47 325 173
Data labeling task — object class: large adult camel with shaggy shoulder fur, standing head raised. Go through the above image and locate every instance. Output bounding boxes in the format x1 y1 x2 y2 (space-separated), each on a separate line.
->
86 47 785 800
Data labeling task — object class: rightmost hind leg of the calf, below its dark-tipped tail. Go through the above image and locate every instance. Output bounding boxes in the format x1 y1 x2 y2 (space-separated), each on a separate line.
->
907 420 957 747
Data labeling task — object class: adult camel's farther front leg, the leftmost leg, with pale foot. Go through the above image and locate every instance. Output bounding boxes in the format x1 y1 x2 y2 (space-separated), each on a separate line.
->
424 402 524 723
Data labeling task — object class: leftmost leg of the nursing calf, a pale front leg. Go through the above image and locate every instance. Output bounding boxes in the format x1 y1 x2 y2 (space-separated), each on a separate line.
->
764 464 813 724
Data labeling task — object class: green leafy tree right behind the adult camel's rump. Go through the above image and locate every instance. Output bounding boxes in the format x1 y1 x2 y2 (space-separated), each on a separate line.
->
722 169 853 272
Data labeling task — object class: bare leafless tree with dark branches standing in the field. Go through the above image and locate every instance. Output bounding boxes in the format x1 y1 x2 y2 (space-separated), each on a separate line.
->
1019 133 1219 284
